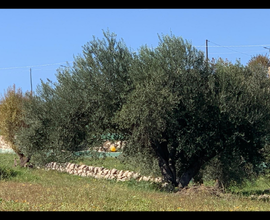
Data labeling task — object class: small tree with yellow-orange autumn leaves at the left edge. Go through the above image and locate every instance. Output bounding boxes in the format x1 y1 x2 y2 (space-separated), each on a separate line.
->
0 85 30 166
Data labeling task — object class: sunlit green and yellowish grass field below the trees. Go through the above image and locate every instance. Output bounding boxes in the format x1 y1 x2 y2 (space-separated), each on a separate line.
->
0 154 270 211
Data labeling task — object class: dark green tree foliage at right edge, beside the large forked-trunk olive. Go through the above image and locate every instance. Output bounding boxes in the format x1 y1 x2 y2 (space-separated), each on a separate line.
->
196 58 269 187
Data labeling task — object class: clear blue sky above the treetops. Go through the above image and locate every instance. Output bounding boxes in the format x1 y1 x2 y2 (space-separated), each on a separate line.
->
0 9 270 95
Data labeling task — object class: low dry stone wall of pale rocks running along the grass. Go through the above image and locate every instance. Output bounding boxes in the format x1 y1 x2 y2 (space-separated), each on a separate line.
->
45 162 162 183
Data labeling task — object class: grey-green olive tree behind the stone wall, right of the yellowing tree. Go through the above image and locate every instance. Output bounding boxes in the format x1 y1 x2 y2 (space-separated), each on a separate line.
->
17 32 132 164
